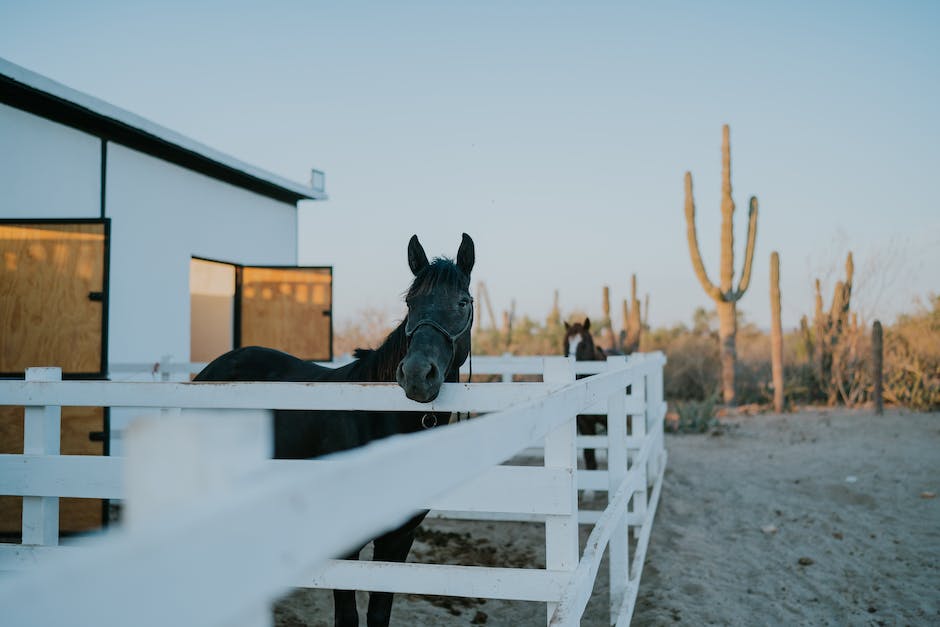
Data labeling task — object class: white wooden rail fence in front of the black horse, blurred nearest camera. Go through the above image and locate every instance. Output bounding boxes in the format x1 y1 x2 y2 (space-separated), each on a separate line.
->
0 354 666 627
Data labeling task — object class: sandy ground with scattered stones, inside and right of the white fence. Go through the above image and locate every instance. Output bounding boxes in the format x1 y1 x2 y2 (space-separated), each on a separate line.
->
275 411 940 627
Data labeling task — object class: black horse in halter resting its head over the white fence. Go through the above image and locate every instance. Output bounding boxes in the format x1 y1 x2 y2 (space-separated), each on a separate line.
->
196 233 475 627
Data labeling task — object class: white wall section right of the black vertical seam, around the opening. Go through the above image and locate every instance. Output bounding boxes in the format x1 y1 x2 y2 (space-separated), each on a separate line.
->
105 143 297 363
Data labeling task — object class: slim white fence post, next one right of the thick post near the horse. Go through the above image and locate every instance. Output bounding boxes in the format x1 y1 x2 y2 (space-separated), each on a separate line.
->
607 356 630 624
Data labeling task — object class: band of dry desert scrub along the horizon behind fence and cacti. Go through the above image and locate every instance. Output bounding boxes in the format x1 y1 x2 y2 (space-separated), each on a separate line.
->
334 295 940 412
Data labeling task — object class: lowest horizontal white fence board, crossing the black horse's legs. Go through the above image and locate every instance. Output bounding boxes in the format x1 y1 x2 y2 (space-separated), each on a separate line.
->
295 560 570 602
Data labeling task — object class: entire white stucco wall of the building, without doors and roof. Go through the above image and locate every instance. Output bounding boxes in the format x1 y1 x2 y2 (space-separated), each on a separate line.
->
0 105 297 455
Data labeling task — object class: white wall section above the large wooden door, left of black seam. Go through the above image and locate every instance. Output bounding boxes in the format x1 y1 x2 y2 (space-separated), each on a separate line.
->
0 104 101 218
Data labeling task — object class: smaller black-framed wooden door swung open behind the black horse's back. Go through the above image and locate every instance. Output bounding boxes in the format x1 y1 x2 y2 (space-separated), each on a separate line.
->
236 266 333 361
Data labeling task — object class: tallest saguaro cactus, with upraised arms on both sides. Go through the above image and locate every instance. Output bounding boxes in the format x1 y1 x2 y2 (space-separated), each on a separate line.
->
685 124 757 405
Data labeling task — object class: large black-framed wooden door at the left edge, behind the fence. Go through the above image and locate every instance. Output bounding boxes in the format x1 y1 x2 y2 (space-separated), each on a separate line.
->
0 220 108 535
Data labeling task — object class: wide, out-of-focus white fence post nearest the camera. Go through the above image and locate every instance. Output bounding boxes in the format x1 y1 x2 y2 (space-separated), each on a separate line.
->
124 410 273 627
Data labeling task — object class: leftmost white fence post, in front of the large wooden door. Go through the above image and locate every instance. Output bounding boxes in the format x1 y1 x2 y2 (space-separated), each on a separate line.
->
23 368 62 546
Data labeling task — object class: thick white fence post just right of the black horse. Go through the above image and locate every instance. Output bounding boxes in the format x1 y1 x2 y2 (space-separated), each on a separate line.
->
542 357 580 624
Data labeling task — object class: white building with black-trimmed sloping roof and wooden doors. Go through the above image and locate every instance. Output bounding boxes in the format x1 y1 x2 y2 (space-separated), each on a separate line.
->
0 59 332 532
